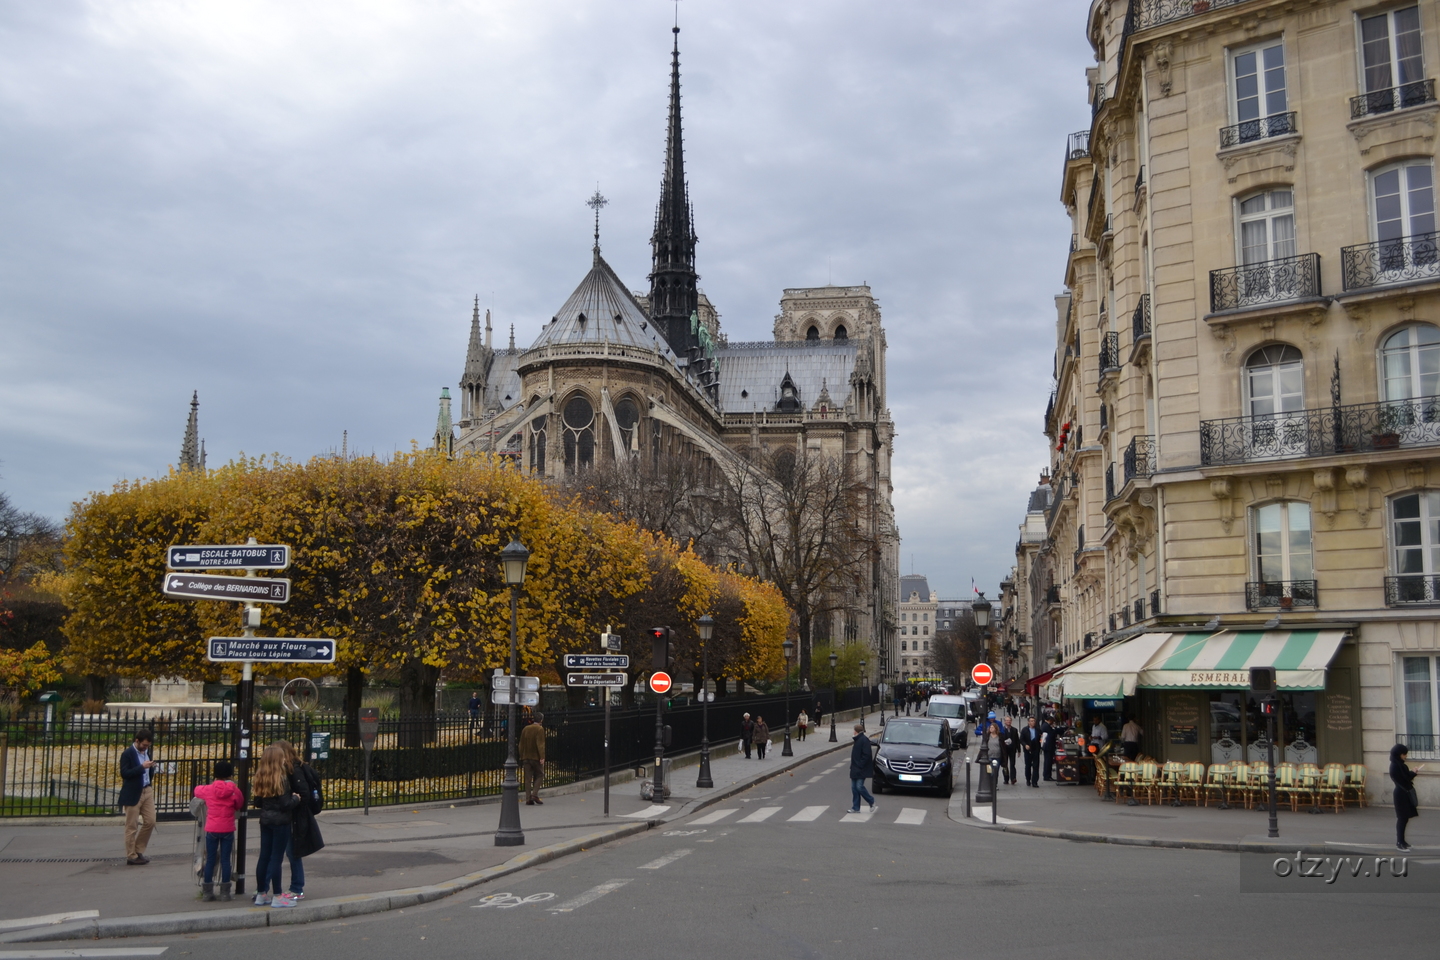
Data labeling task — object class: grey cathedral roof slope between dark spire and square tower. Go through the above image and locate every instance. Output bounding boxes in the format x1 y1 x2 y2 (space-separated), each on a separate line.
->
716 340 860 413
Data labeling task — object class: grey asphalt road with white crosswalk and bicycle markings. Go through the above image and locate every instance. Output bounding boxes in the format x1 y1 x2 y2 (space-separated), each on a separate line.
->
75 756 1440 960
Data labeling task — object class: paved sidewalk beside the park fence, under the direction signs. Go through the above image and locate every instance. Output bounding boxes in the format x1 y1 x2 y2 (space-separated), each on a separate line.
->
0 714 880 943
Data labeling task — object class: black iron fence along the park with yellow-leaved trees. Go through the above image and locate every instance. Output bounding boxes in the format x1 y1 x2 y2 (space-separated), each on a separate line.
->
0 688 823 819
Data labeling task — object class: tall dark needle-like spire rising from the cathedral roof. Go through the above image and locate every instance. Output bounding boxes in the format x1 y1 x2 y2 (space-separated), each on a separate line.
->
649 26 700 364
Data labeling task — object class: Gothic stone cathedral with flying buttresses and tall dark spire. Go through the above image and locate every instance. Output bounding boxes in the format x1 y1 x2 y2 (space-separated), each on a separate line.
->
435 27 899 662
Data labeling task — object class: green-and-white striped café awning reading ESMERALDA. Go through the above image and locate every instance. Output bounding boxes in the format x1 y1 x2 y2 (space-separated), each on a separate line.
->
1136 630 1345 689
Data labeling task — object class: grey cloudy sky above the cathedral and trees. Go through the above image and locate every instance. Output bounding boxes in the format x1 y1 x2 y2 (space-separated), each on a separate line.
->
0 0 1089 596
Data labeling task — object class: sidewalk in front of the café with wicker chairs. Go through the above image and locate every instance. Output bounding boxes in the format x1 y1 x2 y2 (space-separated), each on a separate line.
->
950 750 1440 853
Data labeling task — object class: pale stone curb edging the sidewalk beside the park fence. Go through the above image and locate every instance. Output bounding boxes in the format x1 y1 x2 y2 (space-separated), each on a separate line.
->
0 713 869 943
